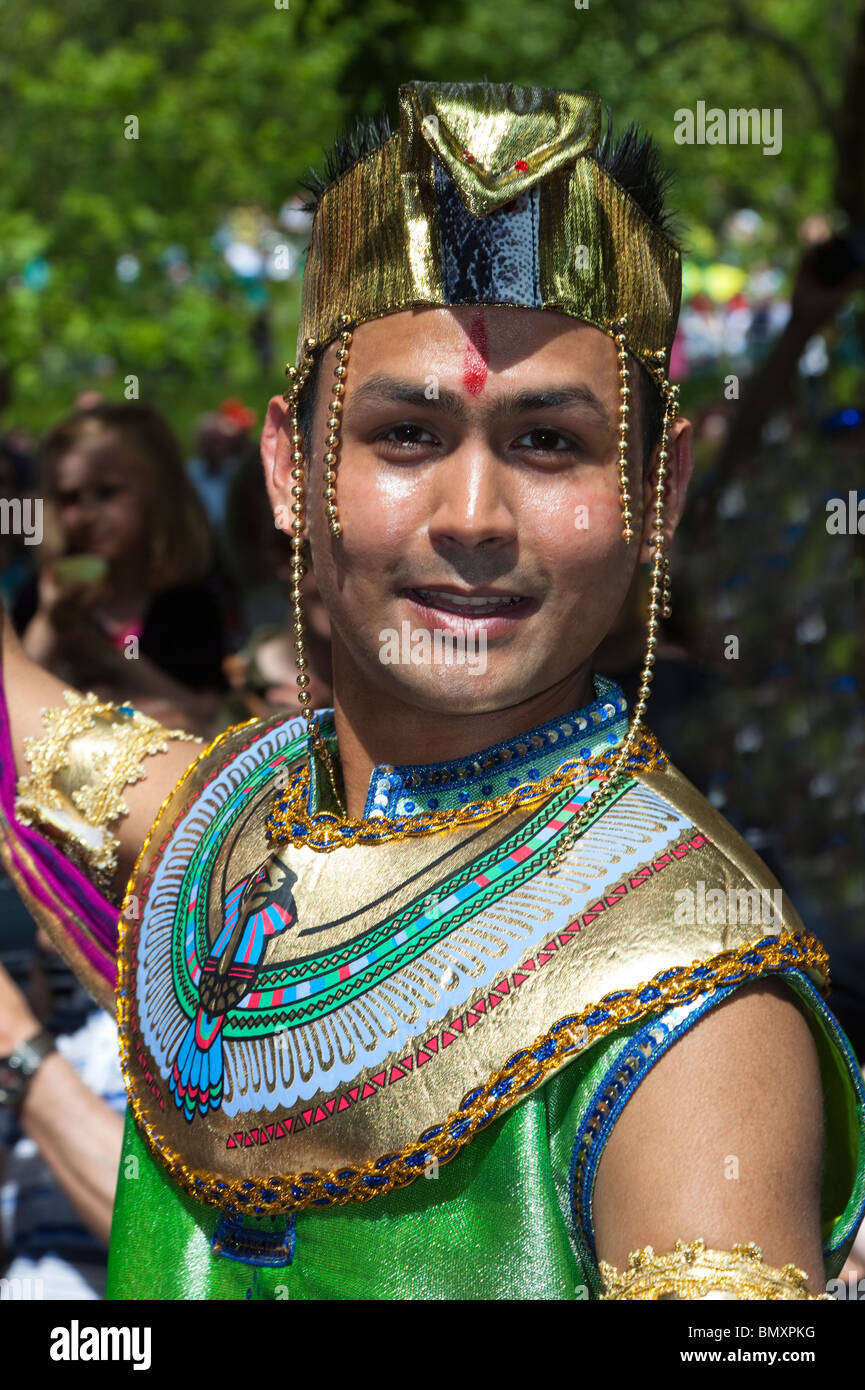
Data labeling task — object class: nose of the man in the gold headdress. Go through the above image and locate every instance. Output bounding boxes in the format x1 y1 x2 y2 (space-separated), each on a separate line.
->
430 442 517 550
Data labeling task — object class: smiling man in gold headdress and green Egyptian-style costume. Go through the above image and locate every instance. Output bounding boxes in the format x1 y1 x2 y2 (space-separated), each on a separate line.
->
0 82 864 1300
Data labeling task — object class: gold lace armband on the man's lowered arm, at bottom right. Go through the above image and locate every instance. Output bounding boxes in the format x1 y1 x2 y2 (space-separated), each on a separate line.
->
598 1240 830 1302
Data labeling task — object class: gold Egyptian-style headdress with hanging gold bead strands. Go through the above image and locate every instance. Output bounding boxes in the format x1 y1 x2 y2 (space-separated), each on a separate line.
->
277 82 681 852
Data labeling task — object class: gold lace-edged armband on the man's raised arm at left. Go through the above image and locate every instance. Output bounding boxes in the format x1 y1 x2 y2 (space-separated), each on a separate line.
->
15 691 202 891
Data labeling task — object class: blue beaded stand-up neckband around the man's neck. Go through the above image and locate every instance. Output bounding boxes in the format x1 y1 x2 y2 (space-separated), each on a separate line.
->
307 674 627 820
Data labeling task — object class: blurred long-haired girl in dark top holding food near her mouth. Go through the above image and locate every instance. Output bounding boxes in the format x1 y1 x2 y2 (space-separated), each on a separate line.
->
14 402 225 733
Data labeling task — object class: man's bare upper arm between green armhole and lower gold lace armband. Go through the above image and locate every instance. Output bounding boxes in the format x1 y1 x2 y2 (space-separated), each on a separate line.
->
594 983 823 1293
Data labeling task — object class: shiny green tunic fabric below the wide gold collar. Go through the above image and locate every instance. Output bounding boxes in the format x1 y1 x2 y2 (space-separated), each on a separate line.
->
107 976 865 1300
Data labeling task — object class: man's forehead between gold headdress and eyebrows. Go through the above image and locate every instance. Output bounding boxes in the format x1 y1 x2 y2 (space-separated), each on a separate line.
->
349 304 616 381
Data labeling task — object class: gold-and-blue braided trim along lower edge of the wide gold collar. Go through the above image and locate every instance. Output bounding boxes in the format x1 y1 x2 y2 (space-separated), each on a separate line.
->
118 929 829 1215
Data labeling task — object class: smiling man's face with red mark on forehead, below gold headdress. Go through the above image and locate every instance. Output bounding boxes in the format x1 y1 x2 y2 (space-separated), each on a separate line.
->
266 306 686 714
